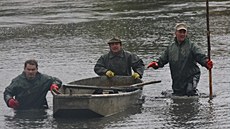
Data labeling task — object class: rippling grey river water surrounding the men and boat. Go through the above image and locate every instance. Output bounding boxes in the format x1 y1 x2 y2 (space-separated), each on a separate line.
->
0 0 230 129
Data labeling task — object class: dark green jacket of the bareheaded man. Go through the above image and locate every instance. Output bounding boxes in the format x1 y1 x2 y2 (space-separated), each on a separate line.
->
4 72 62 109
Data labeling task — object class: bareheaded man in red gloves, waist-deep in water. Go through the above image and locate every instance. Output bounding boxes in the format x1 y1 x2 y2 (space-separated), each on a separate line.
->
4 60 62 110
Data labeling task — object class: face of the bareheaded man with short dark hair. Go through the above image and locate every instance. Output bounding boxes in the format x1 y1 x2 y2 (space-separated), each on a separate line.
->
24 64 38 80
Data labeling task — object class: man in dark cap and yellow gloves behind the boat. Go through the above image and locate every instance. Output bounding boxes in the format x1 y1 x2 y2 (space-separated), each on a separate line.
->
94 37 144 79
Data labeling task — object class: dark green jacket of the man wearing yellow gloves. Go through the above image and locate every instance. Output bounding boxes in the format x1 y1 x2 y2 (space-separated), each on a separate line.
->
94 50 144 77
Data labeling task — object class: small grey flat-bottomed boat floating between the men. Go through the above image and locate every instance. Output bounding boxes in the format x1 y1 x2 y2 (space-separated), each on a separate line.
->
52 77 143 118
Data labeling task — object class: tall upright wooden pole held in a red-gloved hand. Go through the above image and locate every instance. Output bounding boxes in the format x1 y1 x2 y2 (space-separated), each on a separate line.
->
206 0 213 100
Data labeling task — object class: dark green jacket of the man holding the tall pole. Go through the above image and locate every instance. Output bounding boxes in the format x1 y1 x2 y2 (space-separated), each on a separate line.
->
158 38 208 92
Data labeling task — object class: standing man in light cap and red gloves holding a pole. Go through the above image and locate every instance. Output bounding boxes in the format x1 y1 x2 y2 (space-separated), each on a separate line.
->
148 23 213 96
